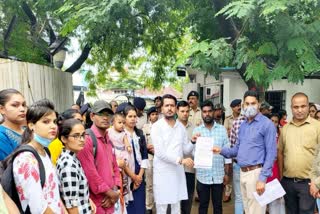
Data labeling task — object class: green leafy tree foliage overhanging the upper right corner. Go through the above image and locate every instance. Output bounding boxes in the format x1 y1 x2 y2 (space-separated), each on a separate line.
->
184 0 320 91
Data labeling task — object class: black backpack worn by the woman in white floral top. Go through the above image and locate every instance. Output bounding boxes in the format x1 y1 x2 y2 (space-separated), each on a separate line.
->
1 145 51 213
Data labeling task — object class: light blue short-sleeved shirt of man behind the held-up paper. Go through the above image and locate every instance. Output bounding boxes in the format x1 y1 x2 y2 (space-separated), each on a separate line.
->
193 123 229 184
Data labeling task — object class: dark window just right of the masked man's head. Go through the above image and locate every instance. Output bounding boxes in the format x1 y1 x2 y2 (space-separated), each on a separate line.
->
265 91 286 113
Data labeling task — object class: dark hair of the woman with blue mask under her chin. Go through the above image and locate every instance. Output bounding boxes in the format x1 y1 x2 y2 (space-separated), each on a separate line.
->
21 99 56 144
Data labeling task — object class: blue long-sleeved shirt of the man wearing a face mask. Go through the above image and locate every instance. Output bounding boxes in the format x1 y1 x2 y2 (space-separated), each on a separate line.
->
220 113 277 182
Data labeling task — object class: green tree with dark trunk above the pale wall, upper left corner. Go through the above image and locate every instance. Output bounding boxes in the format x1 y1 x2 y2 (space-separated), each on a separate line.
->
0 0 90 73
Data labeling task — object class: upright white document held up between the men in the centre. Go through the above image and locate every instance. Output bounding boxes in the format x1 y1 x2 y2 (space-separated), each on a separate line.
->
194 137 213 169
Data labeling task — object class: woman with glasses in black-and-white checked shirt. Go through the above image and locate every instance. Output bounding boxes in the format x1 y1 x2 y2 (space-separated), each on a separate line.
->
57 119 96 213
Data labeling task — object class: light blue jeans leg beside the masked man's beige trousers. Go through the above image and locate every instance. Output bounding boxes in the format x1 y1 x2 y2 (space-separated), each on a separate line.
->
233 163 243 214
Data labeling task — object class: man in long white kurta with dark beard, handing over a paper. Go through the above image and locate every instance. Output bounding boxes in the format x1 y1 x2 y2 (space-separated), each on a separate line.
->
151 95 194 214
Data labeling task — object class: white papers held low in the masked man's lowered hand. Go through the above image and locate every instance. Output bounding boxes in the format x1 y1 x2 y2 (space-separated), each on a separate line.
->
253 179 286 206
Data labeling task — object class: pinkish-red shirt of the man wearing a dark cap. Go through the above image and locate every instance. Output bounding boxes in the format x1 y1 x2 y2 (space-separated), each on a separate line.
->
78 125 120 214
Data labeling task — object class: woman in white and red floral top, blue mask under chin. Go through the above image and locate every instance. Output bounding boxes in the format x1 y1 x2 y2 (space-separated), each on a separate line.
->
13 99 65 214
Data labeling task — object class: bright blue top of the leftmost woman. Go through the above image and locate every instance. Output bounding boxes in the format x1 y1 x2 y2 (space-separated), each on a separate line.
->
0 125 21 161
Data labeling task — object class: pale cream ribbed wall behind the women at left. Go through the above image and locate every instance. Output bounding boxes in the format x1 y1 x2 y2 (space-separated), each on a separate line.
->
0 59 73 112
